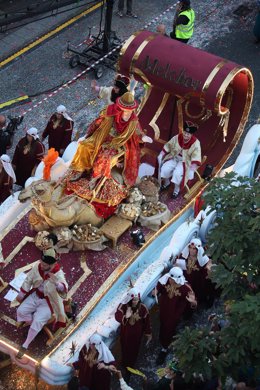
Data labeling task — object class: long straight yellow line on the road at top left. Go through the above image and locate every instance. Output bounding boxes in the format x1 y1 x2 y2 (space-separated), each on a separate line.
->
0 1 103 68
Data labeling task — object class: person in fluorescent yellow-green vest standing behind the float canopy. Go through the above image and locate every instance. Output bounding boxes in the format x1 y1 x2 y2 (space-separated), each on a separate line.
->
170 0 195 43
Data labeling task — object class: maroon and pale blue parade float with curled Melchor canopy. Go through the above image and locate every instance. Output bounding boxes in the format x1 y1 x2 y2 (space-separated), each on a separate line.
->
0 31 260 385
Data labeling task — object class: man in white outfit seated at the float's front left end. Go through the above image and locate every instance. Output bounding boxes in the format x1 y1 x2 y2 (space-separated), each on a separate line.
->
16 249 68 359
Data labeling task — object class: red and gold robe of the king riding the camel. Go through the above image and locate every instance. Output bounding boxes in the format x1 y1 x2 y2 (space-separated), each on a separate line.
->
71 104 142 186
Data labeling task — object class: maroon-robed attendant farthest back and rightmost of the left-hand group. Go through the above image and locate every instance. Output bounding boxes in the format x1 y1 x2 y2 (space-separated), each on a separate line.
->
42 105 74 156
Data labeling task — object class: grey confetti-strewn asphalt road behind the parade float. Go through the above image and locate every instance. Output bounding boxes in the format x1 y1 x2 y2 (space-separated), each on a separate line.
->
0 0 260 163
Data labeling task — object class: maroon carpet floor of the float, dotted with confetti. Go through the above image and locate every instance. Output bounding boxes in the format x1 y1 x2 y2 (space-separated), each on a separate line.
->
0 192 187 358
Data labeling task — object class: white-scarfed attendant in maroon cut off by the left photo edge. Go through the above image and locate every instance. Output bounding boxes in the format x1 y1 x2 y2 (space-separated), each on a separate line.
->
0 154 16 204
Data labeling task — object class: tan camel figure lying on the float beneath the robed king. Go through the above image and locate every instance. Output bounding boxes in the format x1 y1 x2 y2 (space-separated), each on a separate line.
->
18 180 103 231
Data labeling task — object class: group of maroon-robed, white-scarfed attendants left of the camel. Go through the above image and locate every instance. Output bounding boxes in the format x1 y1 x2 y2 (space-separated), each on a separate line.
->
0 105 74 204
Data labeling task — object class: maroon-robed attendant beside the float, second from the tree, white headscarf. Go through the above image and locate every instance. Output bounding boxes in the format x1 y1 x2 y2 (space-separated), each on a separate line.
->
155 267 197 364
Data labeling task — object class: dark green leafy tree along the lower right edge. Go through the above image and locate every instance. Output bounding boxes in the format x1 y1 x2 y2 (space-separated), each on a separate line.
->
174 173 260 380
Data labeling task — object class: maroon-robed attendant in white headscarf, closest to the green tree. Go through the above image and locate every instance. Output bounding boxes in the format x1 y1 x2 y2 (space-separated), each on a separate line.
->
175 238 215 302
